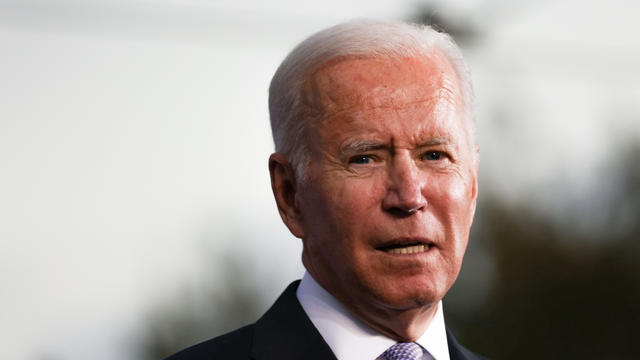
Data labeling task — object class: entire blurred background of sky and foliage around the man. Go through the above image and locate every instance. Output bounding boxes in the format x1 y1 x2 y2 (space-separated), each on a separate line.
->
0 0 640 360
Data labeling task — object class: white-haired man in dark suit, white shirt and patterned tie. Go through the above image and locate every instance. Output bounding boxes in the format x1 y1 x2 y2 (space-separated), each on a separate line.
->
170 21 480 360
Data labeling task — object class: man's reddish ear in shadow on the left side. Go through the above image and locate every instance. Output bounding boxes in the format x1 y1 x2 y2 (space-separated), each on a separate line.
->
269 153 305 239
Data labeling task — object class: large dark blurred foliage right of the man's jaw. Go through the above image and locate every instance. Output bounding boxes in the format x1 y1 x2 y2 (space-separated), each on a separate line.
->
445 143 640 359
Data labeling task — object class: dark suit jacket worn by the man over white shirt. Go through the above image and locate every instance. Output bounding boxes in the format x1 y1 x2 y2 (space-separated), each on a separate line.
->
166 281 484 360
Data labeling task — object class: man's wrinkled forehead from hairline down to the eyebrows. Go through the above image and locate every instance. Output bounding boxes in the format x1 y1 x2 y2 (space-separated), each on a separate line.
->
303 51 469 148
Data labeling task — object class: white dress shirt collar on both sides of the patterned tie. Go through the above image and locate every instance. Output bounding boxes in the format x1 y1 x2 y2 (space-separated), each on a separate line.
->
296 272 449 360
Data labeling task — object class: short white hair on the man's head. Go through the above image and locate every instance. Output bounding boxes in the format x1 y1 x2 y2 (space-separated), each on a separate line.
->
269 20 475 178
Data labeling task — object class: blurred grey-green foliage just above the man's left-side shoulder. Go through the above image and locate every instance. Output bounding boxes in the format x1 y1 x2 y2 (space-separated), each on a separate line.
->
140 253 265 360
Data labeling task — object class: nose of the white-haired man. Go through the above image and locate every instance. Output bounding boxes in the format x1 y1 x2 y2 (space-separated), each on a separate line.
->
382 154 427 216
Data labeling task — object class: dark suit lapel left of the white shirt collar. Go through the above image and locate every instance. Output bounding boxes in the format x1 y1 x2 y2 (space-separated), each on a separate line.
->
251 281 336 360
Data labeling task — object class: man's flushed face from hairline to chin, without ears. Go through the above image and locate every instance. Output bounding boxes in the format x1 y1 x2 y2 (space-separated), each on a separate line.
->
295 51 477 334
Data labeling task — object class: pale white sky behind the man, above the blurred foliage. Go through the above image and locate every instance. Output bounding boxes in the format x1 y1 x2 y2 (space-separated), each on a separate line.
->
0 0 640 360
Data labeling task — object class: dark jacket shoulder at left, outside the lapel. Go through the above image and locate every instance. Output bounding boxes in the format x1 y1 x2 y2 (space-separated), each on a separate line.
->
165 324 254 360
